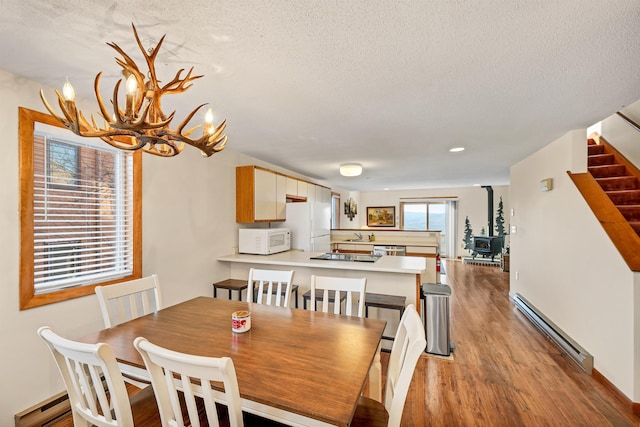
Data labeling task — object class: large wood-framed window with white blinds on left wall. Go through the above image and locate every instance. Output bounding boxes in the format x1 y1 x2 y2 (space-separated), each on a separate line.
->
19 108 142 309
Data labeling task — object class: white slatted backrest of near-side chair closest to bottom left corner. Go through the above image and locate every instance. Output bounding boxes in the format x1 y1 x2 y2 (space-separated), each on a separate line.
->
38 326 133 427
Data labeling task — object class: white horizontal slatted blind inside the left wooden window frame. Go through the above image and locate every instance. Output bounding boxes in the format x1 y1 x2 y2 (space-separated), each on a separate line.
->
33 134 133 295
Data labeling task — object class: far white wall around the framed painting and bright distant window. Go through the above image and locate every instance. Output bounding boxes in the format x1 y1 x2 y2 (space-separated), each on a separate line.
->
340 185 510 256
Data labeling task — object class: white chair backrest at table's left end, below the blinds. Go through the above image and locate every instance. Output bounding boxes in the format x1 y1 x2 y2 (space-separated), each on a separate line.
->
95 274 162 328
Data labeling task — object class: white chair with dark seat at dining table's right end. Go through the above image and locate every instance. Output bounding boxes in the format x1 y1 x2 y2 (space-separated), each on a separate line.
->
351 304 427 427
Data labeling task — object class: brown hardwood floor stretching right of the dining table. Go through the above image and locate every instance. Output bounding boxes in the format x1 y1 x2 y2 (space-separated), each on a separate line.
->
398 260 640 427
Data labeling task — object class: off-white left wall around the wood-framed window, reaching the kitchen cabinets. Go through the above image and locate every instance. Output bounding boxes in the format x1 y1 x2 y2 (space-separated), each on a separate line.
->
0 70 321 426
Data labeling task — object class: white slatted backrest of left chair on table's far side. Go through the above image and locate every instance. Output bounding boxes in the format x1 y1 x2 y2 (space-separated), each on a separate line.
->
247 268 293 307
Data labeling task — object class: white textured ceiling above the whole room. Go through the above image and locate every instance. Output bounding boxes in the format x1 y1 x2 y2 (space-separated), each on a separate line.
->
0 0 640 190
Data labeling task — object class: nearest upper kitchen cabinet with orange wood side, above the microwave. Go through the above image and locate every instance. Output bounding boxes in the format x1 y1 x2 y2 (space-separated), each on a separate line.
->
236 166 287 223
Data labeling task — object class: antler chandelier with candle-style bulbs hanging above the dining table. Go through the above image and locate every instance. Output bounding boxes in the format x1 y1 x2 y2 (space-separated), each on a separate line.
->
40 24 227 157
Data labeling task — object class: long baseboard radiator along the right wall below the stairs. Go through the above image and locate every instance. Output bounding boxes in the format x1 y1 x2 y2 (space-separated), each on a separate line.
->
512 293 593 375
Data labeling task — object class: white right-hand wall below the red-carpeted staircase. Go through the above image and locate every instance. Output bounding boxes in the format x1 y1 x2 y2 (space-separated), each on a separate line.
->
510 130 640 402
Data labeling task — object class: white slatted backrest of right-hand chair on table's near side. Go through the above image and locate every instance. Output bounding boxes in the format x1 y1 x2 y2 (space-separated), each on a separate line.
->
133 337 243 427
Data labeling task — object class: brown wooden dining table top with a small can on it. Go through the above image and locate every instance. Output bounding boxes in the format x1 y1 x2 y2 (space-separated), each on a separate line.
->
79 297 385 426
